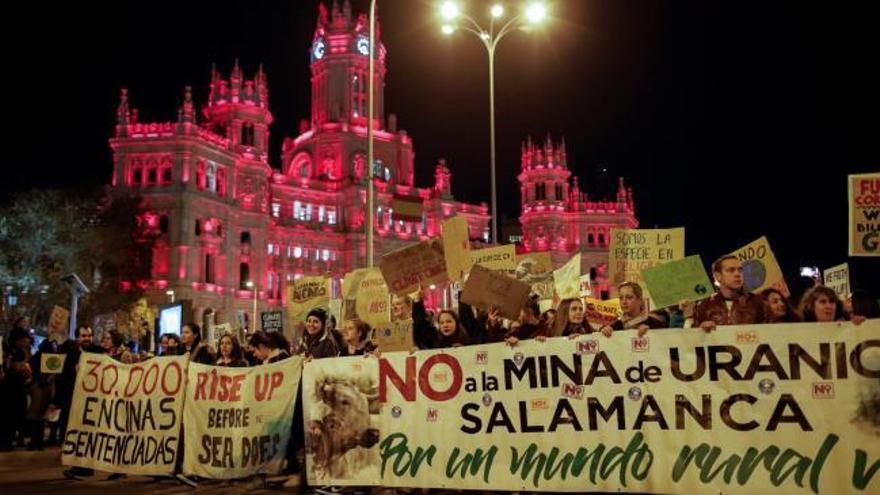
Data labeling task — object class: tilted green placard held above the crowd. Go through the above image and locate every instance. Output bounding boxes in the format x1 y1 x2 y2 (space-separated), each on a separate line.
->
642 255 715 308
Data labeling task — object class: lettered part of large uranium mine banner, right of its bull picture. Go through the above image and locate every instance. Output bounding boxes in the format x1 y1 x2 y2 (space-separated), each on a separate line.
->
376 320 880 493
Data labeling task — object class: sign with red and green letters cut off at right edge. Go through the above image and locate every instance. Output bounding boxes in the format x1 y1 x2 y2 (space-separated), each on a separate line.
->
847 173 880 256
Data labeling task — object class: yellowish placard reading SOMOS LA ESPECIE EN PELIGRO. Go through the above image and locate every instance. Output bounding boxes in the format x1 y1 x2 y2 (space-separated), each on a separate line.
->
608 227 684 287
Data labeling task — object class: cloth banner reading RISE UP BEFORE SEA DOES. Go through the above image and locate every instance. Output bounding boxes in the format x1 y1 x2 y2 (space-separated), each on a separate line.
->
183 356 302 479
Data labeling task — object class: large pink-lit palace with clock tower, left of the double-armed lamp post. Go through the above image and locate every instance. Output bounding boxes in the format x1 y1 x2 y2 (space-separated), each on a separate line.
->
110 2 489 330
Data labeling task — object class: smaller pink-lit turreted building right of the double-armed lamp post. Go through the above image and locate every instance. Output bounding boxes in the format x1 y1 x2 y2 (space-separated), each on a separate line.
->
518 136 639 295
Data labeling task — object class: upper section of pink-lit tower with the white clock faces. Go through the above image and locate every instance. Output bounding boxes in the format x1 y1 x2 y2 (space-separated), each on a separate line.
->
309 0 385 130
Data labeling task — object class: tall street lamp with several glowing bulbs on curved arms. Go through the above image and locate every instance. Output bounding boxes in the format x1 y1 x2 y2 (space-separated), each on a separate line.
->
440 1 547 243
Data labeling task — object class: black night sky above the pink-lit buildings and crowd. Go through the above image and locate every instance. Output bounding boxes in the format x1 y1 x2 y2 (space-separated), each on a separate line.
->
10 0 880 292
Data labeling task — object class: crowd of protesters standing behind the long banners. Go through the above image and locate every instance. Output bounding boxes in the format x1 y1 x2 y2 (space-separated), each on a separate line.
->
0 231 880 494
